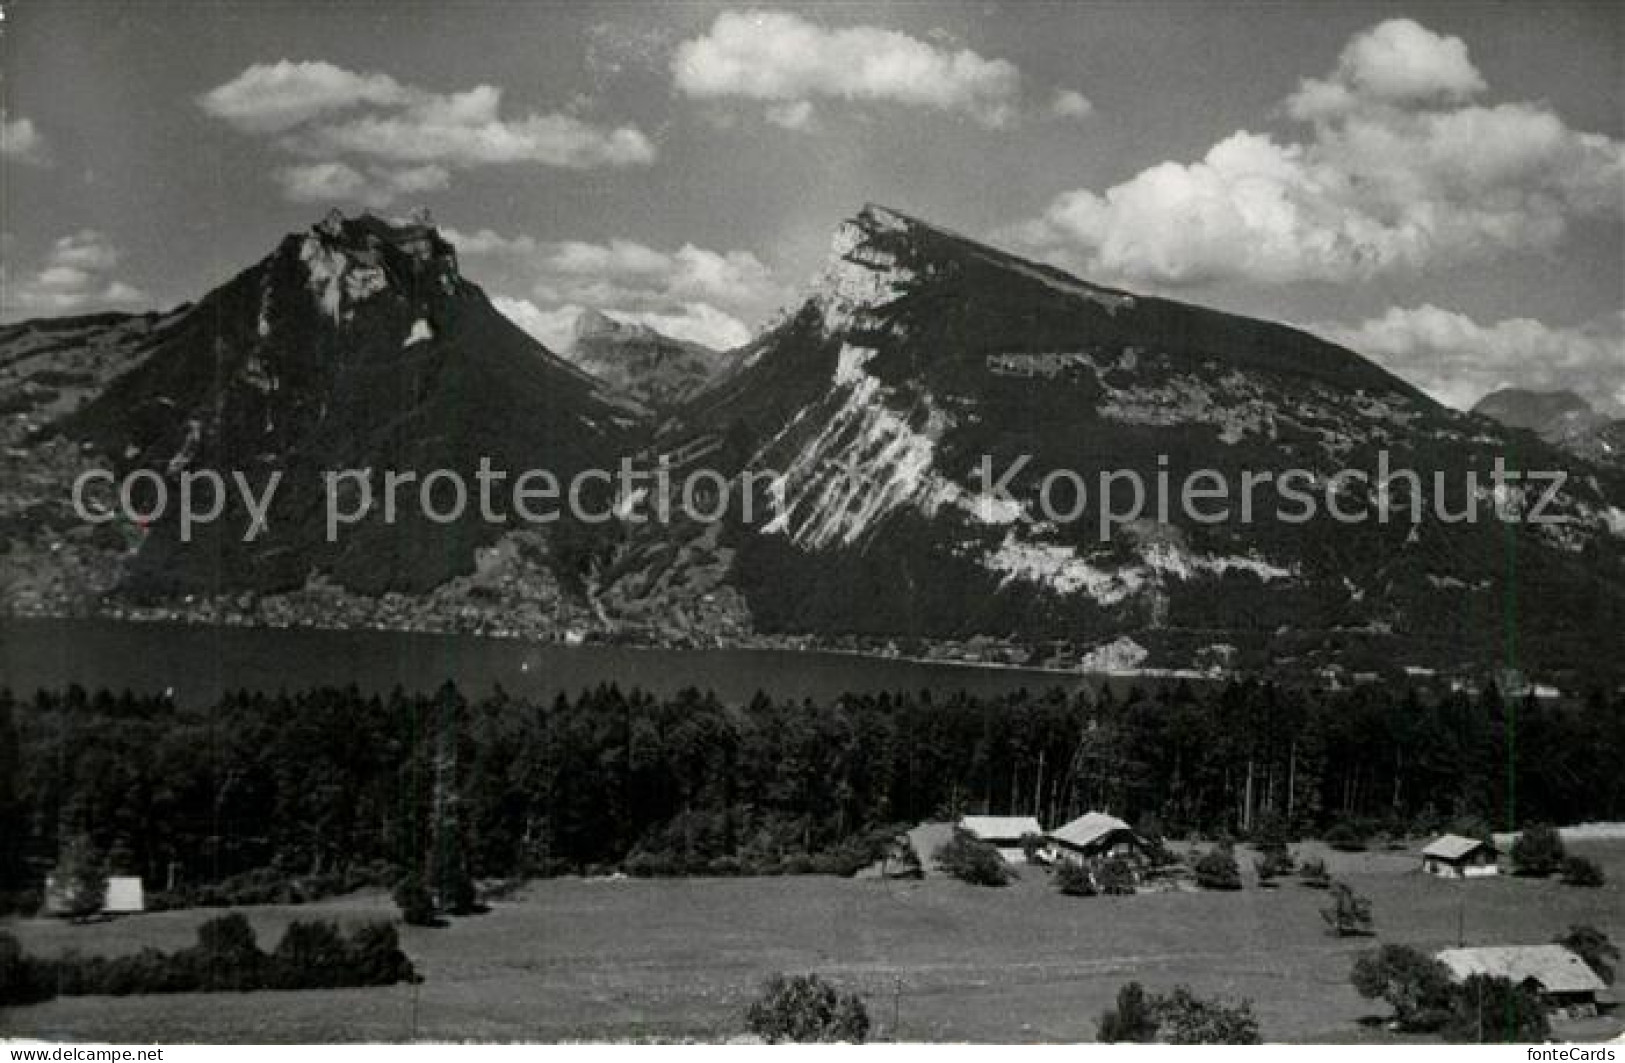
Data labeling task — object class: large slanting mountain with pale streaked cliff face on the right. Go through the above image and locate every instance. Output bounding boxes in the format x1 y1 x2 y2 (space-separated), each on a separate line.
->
606 205 1625 685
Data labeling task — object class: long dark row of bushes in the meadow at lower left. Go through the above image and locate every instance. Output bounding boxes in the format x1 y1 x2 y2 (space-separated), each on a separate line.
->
0 912 418 1004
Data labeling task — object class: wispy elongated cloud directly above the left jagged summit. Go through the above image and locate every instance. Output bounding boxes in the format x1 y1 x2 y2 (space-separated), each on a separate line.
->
198 60 655 206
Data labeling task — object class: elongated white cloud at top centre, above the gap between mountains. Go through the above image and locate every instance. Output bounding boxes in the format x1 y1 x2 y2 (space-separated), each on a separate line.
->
671 11 1022 127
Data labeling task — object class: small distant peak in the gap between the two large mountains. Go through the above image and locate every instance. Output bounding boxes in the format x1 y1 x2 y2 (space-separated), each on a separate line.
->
559 310 733 410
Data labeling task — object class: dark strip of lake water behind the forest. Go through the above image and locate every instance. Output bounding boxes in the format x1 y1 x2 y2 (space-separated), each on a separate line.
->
0 619 1100 705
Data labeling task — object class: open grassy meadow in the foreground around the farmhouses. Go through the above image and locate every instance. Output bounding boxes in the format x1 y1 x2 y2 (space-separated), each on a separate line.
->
0 840 1625 1042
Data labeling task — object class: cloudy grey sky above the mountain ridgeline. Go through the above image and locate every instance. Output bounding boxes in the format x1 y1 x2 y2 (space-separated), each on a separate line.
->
0 0 1625 414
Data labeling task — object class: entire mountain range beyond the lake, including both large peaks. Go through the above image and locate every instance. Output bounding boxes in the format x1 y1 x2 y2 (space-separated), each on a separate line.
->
0 206 1625 689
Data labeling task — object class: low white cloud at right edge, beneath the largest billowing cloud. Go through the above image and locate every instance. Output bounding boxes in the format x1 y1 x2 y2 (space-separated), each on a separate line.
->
1311 304 1625 416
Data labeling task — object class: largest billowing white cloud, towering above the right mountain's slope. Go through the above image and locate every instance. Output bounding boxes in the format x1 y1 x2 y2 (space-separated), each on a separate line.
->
1011 20 1625 286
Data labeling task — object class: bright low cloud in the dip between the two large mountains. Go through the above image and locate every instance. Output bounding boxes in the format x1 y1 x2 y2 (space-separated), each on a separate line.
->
442 229 787 349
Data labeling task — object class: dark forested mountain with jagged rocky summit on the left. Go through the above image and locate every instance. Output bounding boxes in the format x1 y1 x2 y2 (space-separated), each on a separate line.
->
14 213 644 601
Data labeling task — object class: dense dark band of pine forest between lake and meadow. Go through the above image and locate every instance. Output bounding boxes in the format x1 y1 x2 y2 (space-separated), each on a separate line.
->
0 681 1625 904
